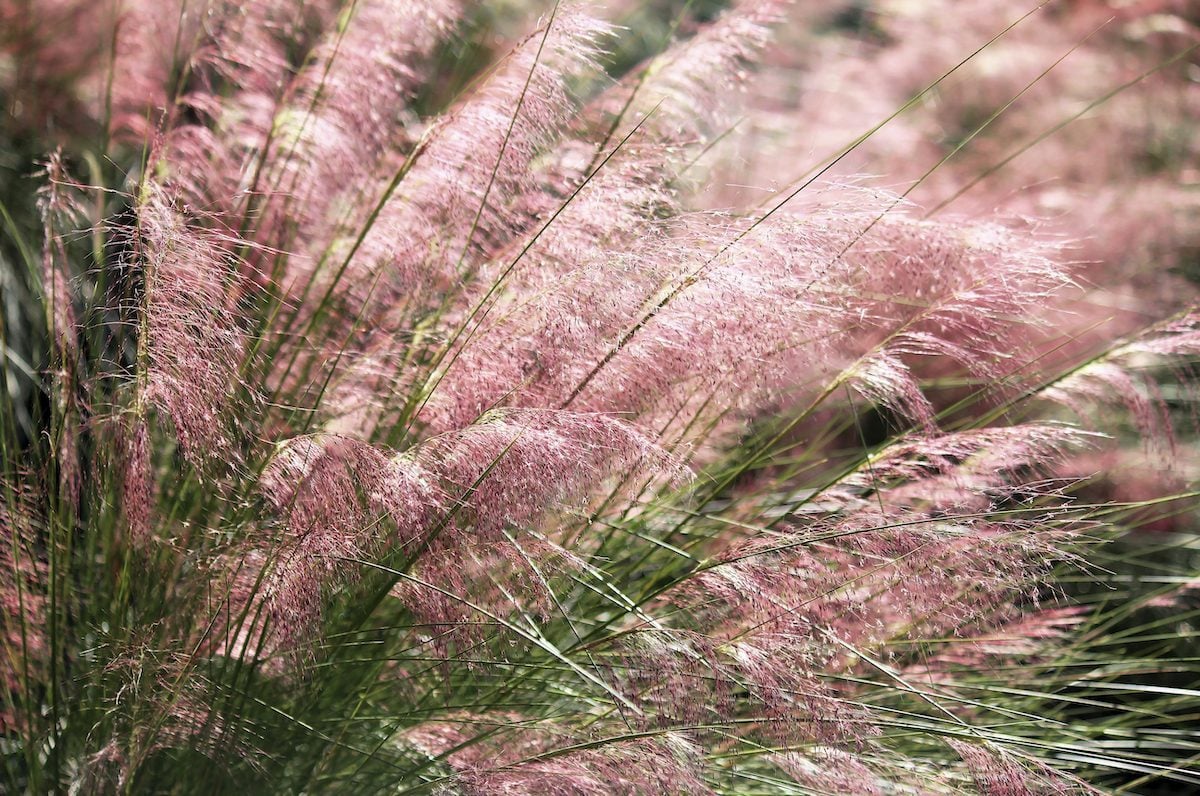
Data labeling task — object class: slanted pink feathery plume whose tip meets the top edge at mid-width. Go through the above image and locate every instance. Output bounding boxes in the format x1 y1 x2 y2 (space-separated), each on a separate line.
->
350 4 607 312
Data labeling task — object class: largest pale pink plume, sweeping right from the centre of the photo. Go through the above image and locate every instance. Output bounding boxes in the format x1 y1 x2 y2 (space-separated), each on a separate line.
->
422 194 1067 444
